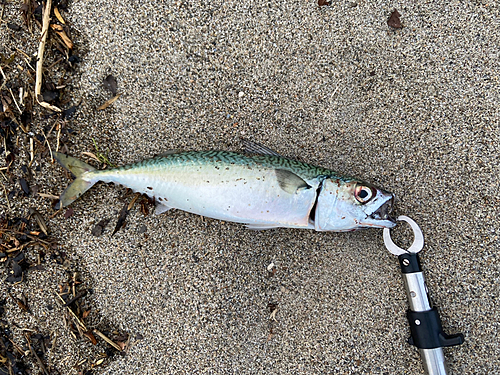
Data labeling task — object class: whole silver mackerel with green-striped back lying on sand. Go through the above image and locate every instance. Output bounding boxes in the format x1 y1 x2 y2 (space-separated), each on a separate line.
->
53 142 396 232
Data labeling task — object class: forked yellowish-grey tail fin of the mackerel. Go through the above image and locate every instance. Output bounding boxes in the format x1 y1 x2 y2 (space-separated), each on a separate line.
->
53 152 97 209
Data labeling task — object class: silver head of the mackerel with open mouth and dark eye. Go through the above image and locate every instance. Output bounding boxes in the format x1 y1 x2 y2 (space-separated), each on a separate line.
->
314 178 396 232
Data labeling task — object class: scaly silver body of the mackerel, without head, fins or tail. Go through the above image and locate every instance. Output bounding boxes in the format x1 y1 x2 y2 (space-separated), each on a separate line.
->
92 151 332 228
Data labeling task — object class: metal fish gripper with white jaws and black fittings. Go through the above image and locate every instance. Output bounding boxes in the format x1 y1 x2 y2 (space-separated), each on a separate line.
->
384 216 464 375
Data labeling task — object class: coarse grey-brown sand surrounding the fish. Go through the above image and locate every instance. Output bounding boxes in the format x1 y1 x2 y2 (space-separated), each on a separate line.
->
0 0 500 374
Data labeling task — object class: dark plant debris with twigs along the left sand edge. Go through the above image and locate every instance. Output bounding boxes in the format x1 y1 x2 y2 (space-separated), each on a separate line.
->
0 0 131 375
